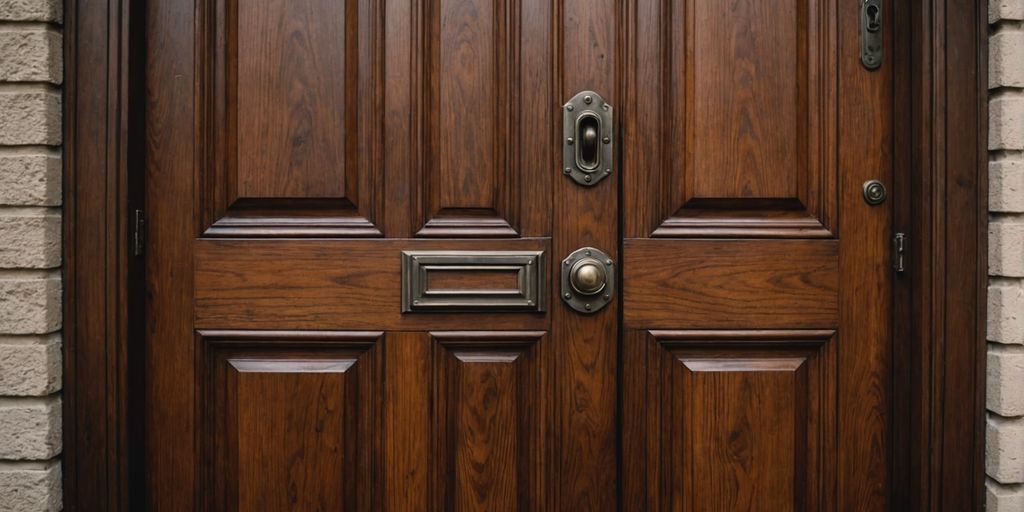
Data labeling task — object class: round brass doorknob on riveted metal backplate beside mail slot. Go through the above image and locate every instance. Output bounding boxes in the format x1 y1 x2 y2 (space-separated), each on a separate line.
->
562 247 615 313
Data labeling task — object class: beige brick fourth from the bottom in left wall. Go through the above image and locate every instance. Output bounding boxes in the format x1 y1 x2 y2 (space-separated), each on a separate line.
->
0 271 61 334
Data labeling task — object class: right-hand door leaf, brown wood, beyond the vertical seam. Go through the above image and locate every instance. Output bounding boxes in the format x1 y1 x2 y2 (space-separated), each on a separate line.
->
622 0 893 510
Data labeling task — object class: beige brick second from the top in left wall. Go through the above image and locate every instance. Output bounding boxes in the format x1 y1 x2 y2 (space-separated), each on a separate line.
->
0 27 63 84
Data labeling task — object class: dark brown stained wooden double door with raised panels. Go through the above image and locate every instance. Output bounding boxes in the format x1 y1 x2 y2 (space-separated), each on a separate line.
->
144 0 892 510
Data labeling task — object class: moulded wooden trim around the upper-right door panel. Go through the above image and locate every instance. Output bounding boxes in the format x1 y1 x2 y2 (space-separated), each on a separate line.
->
623 0 839 239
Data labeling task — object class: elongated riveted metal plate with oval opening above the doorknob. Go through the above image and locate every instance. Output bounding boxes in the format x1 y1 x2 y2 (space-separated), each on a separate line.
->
562 91 614 186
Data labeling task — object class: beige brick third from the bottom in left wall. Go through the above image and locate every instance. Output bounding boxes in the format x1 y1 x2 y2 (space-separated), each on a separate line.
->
0 334 61 396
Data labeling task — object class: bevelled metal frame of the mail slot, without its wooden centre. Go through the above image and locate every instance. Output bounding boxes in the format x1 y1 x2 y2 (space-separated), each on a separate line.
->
401 251 547 313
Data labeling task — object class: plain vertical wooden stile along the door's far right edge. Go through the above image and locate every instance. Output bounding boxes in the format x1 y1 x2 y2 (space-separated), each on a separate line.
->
838 3 899 510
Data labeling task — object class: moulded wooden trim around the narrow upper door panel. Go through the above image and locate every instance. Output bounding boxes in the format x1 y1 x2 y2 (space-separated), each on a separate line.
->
413 0 523 238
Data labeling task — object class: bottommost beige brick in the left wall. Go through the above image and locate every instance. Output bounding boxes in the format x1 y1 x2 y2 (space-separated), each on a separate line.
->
0 460 63 512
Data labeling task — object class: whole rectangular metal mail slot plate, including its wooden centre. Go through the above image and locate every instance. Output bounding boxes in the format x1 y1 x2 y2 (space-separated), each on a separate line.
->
401 251 547 313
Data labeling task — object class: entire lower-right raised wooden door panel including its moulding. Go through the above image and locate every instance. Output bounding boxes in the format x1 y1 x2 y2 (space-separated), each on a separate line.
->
623 330 838 511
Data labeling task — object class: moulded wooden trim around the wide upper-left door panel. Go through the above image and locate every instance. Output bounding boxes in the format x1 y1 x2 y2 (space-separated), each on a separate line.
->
197 0 384 238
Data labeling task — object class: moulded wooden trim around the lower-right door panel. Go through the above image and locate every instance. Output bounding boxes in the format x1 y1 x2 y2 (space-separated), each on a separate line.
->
623 330 839 510
